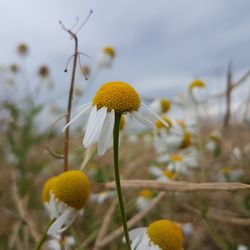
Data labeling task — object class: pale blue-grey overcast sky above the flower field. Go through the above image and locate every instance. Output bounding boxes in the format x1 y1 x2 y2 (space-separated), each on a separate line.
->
0 0 250 103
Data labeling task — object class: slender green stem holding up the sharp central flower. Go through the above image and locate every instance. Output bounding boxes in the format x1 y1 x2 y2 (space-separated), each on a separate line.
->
113 113 131 250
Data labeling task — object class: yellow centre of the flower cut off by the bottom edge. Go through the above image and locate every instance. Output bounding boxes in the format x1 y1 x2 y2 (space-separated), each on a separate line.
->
147 220 183 250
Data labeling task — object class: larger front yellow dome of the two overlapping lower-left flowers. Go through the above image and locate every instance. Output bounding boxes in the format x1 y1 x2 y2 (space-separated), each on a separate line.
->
52 170 90 209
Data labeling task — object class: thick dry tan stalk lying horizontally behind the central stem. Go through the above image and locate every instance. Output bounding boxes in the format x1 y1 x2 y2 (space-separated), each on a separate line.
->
100 180 250 192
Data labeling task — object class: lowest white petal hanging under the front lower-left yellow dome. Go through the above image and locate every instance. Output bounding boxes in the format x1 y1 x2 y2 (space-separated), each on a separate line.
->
47 208 76 236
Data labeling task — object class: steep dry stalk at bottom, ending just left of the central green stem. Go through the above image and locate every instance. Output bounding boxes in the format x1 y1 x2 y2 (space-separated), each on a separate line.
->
93 199 117 250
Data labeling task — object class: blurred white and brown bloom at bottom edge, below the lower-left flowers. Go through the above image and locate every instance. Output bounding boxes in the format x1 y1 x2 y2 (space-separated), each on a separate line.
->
47 235 76 250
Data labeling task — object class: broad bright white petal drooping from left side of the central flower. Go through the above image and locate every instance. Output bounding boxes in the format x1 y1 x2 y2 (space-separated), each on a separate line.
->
83 107 107 147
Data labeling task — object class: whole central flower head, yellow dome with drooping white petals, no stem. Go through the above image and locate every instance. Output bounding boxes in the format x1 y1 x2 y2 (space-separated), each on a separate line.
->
65 82 168 155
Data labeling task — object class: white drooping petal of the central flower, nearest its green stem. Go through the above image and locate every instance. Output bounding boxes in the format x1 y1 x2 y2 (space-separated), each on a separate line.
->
98 110 115 155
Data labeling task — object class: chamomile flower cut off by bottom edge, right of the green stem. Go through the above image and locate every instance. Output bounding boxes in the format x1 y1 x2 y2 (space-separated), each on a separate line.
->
129 220 183 250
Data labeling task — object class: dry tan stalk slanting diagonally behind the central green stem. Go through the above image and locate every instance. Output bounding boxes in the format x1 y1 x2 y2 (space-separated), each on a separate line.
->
98 192 165 248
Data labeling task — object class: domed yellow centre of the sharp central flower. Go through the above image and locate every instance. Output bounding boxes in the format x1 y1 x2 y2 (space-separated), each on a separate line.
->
92 82 141 113
